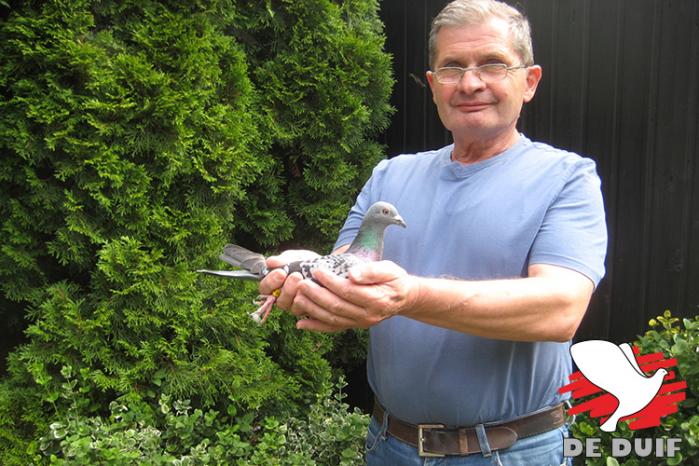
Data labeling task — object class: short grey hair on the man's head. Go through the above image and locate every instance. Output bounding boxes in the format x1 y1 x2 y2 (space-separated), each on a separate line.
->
429 0 534 67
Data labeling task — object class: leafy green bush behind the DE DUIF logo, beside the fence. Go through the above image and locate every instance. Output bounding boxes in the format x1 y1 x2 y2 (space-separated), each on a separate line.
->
571 311 699 466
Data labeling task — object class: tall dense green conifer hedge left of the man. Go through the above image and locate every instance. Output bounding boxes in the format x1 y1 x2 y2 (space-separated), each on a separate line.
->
0 0 392 458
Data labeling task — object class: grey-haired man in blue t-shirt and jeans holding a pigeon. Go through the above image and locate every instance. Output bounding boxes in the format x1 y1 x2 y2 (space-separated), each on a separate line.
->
260 0 606 466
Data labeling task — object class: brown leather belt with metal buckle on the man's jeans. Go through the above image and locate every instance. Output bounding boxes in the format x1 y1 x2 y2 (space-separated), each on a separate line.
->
373 401 565 456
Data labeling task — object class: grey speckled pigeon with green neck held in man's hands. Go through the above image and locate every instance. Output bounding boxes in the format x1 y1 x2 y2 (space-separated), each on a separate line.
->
197 201 407 324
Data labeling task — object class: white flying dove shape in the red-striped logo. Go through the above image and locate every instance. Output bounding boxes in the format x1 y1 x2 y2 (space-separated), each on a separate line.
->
570 340 667 432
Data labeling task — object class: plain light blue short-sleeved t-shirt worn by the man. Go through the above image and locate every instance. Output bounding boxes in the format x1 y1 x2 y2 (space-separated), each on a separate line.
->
335 136 607 426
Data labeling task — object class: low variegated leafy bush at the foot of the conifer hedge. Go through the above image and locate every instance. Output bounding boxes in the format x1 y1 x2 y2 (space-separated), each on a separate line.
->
37 367 369 466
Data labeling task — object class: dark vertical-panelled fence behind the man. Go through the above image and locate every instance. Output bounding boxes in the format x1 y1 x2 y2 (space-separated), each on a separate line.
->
381 0 699 342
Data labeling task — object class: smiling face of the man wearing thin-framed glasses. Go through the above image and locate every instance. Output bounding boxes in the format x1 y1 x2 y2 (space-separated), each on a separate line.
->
427 18 541 140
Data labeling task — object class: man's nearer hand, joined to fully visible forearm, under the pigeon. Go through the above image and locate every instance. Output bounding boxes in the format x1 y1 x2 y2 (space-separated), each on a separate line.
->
285 261 418 332
